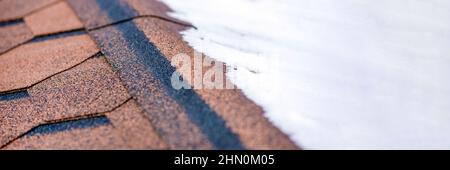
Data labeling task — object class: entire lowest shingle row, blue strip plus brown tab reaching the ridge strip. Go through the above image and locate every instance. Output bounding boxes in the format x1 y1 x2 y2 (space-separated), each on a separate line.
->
5 100 166 149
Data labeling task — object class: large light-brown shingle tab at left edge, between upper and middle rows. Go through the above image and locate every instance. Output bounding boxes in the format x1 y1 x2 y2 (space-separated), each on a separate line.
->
0 35 98 92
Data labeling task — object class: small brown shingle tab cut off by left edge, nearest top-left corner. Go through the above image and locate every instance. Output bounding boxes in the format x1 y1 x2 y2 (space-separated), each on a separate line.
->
0 22 33 54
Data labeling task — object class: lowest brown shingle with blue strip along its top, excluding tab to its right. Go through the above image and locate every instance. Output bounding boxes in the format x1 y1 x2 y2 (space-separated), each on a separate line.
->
5 117 128 150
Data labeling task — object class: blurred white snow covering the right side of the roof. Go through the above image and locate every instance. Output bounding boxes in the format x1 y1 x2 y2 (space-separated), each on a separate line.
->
162 0 450 149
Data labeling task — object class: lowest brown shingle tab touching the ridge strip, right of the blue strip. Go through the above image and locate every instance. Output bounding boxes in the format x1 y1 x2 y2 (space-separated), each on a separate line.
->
106 100 166 149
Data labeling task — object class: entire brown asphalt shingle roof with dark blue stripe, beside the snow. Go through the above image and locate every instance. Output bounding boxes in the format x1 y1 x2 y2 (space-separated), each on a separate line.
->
0 0 298 149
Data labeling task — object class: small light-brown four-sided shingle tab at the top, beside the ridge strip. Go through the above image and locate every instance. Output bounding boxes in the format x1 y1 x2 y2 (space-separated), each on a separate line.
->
24 1 83 36
